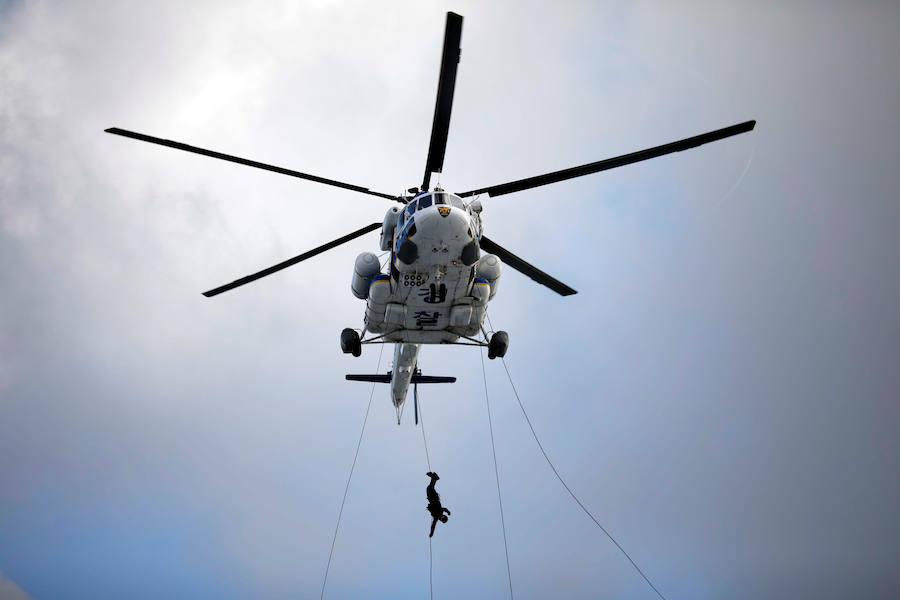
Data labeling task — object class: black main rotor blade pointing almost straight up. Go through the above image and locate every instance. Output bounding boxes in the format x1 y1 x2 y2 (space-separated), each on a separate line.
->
422 12 462 190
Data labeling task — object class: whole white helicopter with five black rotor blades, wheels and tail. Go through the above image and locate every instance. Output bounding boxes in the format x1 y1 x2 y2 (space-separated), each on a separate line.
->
105 12 756 424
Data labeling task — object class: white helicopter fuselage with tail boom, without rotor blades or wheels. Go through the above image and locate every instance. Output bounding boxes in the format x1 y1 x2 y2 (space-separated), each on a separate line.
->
351 189 501 409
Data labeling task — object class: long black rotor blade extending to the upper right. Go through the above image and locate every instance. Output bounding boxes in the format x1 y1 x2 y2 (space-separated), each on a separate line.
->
459 121 756 197
